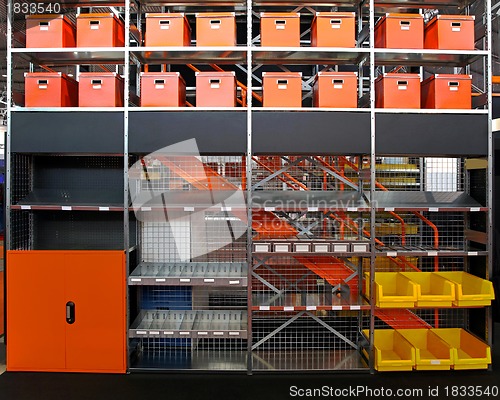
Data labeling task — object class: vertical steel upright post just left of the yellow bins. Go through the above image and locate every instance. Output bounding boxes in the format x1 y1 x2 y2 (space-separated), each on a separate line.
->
368 0 377 373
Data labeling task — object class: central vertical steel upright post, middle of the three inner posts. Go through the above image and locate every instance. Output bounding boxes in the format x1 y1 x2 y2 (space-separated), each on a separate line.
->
245 0 253 375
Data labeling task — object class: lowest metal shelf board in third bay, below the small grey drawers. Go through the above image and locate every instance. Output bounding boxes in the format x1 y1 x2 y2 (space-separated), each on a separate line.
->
252 292 370 316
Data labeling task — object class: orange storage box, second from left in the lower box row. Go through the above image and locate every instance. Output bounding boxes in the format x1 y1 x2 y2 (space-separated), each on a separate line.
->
78 72 123 107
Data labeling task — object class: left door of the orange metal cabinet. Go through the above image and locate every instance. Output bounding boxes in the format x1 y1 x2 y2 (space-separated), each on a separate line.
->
7 251 66 371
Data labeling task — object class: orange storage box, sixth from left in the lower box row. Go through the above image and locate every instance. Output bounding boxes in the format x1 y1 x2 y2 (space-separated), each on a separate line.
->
313 72 358 108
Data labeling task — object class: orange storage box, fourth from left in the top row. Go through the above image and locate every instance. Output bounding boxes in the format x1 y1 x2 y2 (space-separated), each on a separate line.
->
196 13 236 46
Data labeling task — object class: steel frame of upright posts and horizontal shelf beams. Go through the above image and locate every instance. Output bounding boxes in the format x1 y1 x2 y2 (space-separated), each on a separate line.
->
6 0 493 373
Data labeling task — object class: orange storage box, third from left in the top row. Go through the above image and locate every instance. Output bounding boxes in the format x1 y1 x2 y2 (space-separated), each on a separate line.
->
144 13 191 46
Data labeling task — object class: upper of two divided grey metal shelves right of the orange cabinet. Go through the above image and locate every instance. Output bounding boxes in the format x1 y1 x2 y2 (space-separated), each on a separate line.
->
128 262 247 287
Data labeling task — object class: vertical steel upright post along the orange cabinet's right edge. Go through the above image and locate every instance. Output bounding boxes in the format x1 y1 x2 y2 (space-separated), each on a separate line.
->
123 1 130 368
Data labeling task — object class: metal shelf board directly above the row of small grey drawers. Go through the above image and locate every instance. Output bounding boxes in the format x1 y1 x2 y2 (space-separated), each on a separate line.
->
252 190 370 212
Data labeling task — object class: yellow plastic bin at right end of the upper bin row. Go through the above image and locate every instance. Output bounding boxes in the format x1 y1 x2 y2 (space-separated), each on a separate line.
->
436 272 495 307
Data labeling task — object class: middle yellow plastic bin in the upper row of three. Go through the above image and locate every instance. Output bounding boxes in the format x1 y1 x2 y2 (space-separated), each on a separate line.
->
401 272 455 307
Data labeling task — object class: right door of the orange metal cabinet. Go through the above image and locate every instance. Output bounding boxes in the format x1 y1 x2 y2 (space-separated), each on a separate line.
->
65 251 126 372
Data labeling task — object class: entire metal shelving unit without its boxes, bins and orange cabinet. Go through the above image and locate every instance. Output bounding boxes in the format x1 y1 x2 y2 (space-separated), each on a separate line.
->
6 0 492 373
